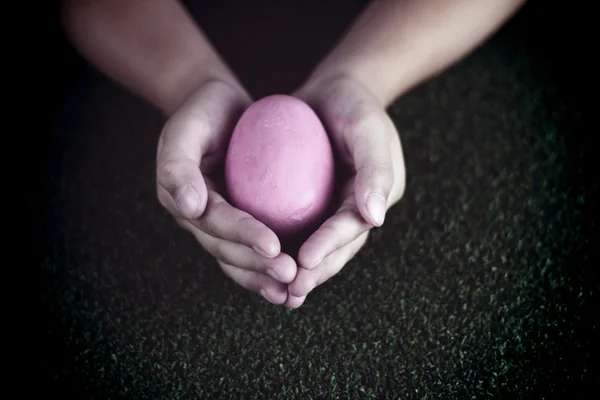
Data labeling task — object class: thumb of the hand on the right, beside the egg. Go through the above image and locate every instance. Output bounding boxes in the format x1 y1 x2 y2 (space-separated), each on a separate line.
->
348 112 394 226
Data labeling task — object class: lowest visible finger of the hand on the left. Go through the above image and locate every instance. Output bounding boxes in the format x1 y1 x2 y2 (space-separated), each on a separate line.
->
219 261 287 304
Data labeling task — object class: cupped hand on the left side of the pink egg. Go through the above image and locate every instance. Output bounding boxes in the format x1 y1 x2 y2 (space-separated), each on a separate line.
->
156 80 297 304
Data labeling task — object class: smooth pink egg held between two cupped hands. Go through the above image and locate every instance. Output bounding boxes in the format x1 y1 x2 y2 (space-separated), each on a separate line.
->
225 95 335 242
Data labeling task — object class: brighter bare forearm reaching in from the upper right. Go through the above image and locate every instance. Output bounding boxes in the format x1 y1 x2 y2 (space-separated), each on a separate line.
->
311 0 525 106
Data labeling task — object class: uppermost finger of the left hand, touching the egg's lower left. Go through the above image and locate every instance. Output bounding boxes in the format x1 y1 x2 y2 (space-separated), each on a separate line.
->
159 182 281 258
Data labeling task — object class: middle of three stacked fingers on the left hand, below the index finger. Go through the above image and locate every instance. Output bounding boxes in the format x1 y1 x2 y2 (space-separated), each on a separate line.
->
179 220 297 283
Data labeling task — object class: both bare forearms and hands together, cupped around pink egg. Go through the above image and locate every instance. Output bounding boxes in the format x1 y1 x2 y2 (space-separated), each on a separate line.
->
62 0 524 308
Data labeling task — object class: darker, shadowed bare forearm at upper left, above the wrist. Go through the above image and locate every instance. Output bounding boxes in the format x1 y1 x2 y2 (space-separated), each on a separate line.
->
62 0 237 114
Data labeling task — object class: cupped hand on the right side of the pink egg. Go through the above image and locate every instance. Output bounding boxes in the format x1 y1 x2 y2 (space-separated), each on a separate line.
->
284 76 406 308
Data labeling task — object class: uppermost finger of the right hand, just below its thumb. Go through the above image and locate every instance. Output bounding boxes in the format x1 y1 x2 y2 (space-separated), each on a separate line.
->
298 190 373 269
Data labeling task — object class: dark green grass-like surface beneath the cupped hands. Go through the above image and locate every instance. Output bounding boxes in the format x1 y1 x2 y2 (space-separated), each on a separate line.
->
40 1 598 399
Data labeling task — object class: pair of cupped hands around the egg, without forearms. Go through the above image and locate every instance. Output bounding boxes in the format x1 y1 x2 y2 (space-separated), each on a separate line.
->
157 76 405 308
